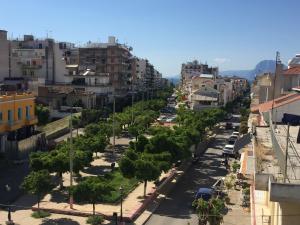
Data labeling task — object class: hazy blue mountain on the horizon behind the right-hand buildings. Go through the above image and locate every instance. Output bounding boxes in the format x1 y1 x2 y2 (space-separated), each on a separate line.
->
220 60 286 80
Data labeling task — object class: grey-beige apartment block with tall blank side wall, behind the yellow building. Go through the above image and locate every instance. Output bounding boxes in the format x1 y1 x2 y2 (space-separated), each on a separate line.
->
0 30 74 91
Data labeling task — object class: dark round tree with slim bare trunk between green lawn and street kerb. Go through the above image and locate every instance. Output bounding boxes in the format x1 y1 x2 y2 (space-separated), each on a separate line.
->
135 159 161 197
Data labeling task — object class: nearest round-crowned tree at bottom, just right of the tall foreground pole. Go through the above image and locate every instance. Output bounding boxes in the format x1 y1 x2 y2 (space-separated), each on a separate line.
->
71 177 113 215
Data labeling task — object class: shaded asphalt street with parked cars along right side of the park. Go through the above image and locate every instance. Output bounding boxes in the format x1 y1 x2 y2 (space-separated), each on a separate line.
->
146 131 232 225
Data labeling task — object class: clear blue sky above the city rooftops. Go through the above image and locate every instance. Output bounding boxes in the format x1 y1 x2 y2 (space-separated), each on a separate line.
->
0 0 300 76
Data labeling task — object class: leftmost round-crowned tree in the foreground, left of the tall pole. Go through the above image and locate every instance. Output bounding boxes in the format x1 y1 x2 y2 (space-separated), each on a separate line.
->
21 170 53 210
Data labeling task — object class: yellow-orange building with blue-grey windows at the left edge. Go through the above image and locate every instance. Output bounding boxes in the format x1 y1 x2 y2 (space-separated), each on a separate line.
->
0 93 37 152
